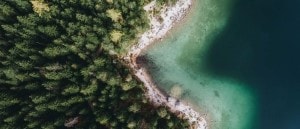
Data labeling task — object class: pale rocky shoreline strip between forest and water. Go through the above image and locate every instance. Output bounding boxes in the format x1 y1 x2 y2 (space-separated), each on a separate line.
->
124 0 208 129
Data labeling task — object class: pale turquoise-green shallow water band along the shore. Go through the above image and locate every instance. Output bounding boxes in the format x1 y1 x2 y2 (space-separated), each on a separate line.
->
145 0 257 129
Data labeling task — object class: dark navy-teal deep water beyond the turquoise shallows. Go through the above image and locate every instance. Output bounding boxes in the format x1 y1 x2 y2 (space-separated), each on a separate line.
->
204 0 300 129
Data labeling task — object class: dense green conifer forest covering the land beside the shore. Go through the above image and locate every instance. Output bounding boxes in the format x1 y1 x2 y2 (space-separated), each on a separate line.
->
0 0 188 129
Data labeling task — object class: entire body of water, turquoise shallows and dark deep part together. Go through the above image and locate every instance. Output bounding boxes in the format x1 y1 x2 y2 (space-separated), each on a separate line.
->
144 0 300 129
